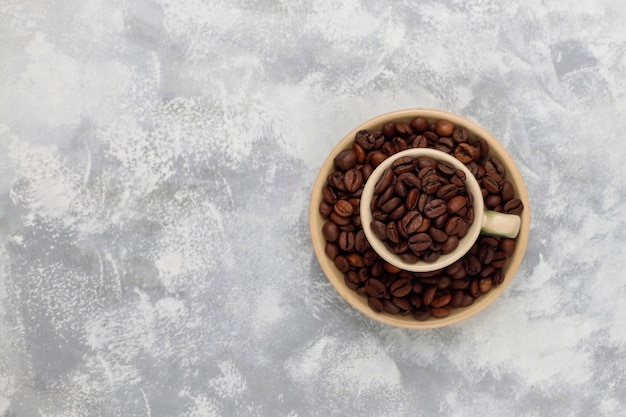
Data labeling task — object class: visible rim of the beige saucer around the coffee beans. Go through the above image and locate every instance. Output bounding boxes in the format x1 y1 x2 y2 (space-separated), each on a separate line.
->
309 109 530 329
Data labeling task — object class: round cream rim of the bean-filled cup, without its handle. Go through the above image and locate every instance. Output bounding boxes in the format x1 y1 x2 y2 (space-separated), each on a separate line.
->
359 148 484 272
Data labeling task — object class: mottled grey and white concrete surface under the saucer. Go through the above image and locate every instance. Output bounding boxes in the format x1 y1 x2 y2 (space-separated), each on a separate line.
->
0 0 626 417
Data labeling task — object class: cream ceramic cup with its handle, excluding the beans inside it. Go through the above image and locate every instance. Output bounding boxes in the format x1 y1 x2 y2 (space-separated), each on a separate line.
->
360 148 520 272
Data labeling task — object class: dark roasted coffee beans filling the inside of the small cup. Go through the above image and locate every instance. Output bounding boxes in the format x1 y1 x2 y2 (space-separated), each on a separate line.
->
370 156 474 263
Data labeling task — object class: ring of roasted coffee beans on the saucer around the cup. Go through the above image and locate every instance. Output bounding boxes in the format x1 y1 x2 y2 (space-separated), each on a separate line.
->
319 117 524 320
